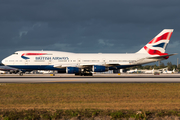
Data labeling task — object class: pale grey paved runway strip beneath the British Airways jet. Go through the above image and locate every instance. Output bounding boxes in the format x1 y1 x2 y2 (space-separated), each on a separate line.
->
0 74 180 83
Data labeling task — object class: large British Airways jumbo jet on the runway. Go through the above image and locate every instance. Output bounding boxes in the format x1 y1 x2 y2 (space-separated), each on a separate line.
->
2 29 175 76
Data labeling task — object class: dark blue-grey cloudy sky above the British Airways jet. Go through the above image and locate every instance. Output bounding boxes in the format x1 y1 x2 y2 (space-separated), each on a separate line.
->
0 0 180 64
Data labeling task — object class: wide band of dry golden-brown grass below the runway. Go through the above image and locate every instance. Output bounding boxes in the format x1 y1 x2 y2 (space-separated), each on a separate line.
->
0 83 180 110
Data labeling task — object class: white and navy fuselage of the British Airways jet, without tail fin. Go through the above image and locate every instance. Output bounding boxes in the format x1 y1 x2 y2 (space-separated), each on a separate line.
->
2 51 160 70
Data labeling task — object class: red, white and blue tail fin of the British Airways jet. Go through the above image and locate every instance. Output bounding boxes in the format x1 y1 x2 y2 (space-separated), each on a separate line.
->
137 29 173 56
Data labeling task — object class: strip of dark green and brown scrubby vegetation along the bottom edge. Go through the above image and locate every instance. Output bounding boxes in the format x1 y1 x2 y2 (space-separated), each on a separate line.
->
0 109 180 120
